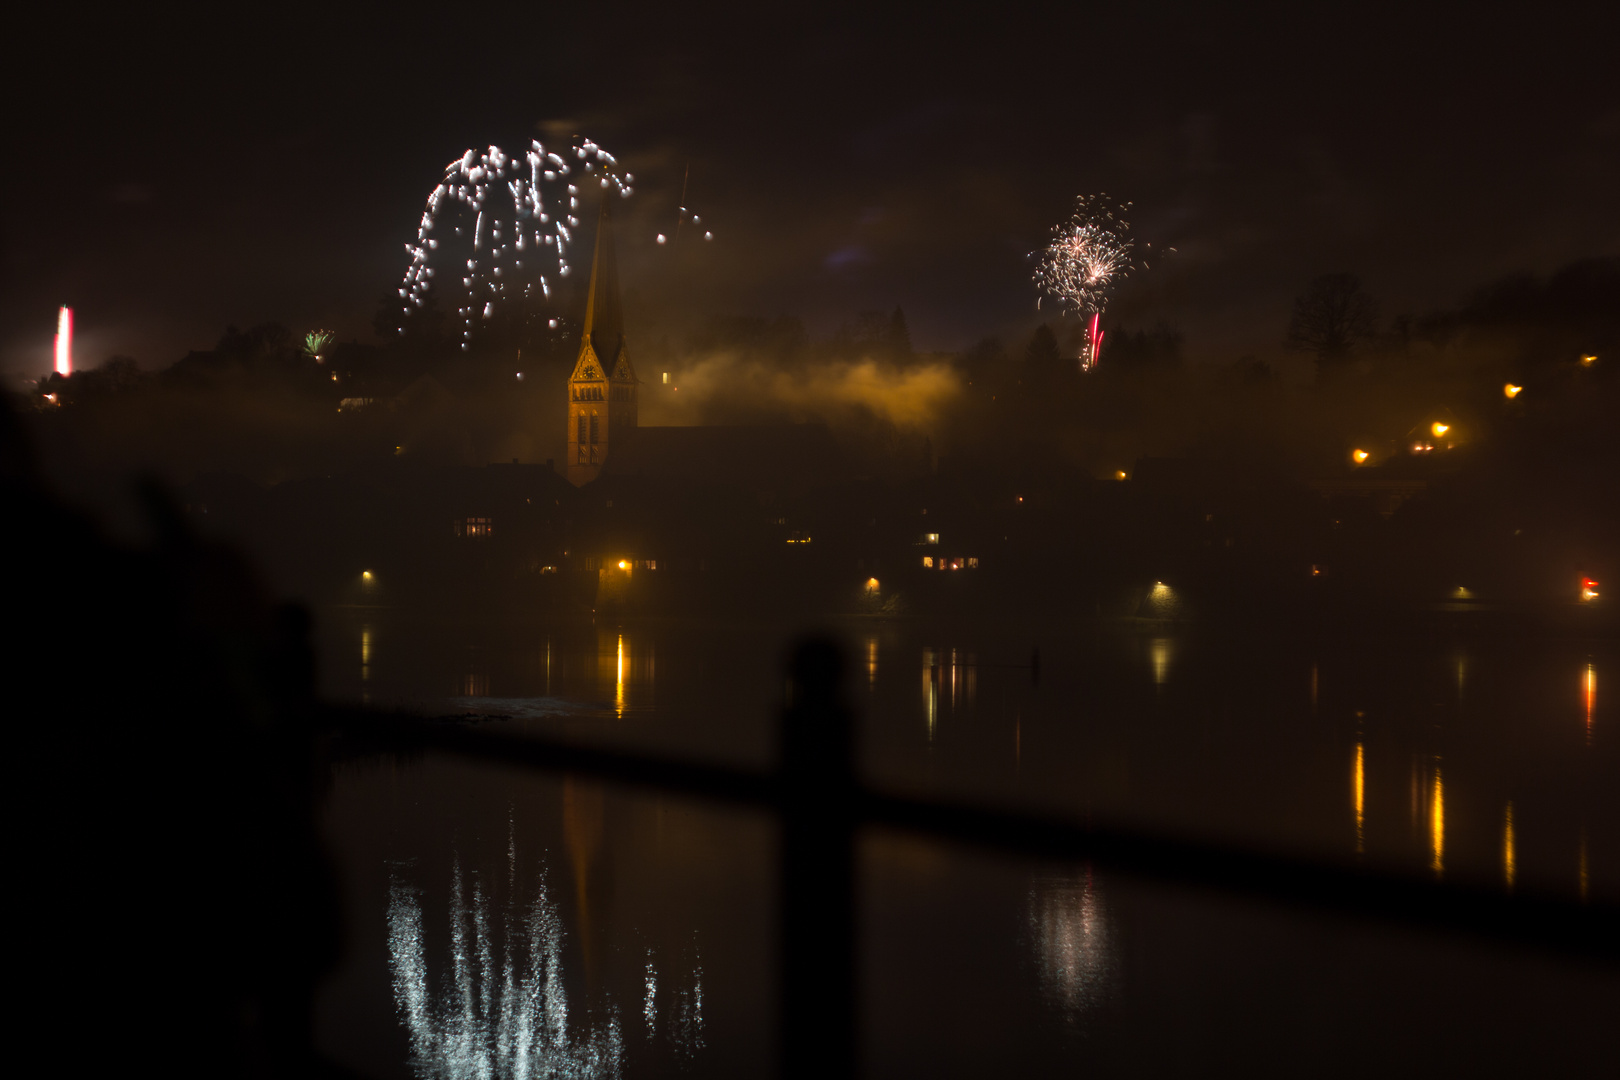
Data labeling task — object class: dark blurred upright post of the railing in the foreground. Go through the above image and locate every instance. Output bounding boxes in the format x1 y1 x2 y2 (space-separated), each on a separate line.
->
781 640 855 1078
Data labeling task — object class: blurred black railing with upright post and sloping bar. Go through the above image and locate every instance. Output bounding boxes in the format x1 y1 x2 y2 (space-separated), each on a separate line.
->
340 641 1620 1077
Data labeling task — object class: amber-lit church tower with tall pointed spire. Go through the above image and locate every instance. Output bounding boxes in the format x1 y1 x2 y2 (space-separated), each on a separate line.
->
567 200 638 487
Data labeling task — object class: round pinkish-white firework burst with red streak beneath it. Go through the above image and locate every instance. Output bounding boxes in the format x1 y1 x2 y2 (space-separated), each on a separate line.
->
1035 194 1134 371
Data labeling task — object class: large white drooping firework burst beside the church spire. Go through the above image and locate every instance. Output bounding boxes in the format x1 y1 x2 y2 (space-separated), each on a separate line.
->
399 139 635 350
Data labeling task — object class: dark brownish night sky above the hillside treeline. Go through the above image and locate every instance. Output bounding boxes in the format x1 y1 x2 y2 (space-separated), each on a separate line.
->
0 3 1620 374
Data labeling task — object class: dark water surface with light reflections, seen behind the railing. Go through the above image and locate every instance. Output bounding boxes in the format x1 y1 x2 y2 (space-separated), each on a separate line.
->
319 609 1620 1077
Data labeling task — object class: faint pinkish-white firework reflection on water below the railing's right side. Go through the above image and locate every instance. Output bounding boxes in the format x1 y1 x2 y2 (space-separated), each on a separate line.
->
1029 870 1115 1020
